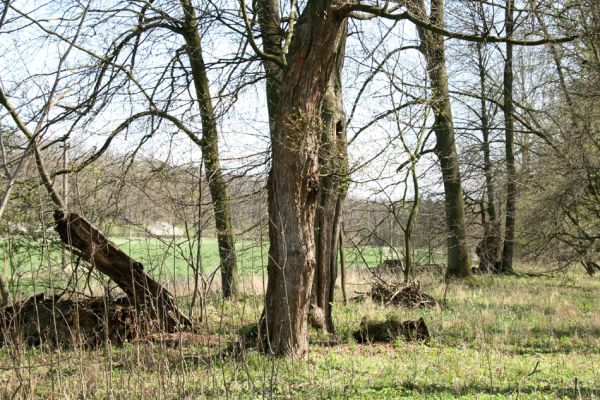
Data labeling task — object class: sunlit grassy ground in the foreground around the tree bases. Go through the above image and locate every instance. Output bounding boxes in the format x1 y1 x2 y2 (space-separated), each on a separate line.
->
0 270 600 399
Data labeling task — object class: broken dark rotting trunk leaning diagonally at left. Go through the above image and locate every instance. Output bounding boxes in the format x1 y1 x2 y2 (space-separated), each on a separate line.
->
54 210 192 332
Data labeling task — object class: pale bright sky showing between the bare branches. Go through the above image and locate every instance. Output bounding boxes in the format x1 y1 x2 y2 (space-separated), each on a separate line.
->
0 0 552 203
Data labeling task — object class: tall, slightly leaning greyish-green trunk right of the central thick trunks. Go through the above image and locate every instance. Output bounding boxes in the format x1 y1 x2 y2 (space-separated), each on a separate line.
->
407 0 472 278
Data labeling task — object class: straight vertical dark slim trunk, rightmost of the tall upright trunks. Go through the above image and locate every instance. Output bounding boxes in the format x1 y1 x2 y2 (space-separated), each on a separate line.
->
501 0 517 273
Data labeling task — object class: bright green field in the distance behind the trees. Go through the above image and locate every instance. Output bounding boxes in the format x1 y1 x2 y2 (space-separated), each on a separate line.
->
0 237 443 291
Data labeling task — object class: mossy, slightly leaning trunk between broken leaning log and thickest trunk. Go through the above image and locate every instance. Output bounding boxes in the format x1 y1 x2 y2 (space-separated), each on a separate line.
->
181 0 239 298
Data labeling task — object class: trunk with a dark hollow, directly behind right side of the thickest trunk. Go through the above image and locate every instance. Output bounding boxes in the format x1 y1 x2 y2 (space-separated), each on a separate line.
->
312 22 348 332
